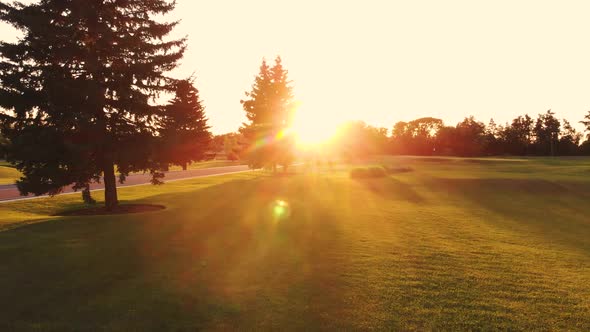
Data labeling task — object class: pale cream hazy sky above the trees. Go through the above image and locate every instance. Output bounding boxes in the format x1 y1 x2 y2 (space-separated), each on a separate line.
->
0 0 590 133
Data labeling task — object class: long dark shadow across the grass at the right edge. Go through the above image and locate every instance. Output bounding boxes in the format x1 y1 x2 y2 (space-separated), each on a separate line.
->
426 178 590 254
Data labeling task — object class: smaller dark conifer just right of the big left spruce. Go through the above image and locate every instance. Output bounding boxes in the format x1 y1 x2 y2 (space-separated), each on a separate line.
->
159 80 211 170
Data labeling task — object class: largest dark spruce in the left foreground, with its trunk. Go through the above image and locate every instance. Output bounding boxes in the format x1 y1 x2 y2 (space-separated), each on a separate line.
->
0 0 185 209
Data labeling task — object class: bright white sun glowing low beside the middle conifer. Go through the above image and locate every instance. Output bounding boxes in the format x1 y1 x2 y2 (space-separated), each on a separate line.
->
291 107 336 146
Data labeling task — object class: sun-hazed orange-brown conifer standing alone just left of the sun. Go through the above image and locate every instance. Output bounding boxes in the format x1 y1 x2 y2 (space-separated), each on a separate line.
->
241 57 294 170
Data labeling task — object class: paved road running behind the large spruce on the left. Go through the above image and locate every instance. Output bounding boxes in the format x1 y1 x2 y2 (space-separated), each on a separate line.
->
0 165 248 202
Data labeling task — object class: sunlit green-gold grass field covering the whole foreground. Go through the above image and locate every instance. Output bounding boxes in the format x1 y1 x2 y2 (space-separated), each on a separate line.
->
0 157 590 331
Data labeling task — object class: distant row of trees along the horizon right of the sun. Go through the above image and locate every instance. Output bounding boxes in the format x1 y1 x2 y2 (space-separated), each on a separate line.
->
333 110 590 157
